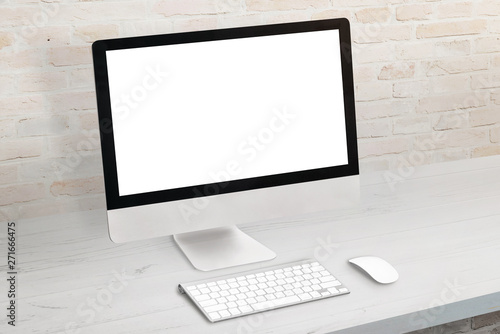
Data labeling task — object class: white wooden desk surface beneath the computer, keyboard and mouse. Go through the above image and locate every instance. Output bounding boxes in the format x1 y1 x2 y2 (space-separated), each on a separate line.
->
0 156 500 334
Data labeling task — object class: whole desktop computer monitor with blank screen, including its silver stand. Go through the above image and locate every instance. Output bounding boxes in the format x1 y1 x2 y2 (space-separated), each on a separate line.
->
92 19 359 270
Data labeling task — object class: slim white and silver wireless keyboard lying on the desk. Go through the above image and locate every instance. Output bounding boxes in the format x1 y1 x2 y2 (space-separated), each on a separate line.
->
179 260 349 322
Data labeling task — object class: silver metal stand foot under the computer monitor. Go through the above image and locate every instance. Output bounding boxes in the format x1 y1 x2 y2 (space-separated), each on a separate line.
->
174 226 276 271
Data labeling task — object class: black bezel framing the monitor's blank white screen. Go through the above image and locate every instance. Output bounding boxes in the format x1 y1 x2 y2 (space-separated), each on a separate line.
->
92 18 359 210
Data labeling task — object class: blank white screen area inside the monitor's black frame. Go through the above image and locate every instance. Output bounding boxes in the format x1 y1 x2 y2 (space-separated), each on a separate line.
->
106 30 348 196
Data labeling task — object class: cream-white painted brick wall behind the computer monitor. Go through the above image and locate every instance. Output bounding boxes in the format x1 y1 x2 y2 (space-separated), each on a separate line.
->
0 0 500 219
